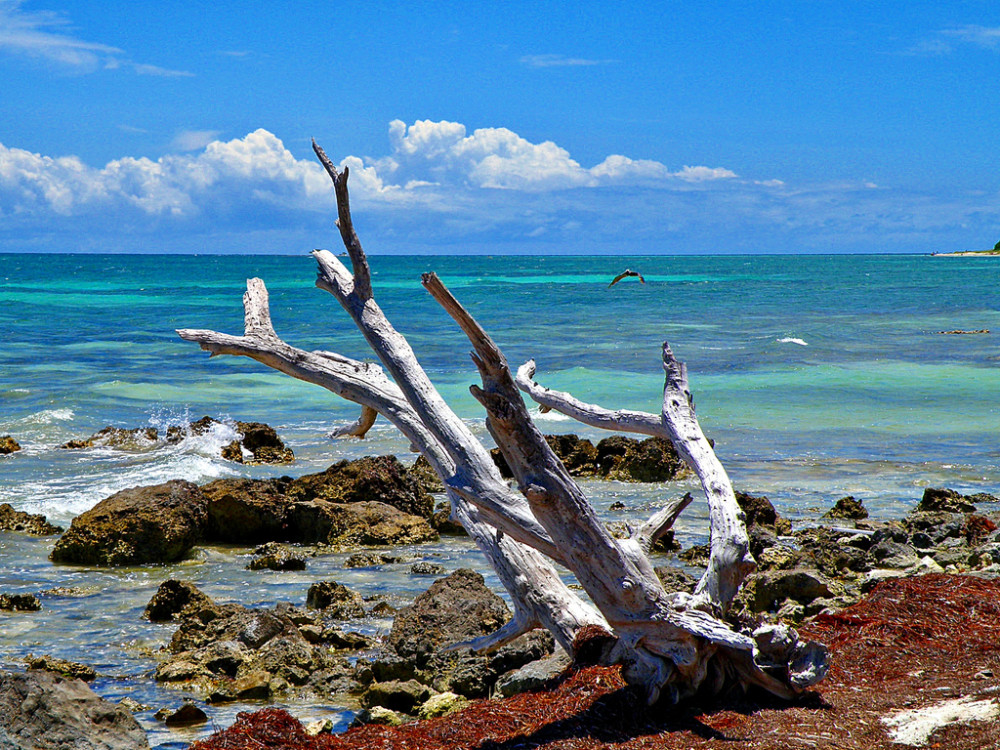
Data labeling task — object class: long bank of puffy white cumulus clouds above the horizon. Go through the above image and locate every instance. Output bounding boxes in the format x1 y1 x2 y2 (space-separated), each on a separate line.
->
0 121 984 253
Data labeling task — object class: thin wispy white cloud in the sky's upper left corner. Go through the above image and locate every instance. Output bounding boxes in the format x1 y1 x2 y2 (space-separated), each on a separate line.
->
0 0 193 76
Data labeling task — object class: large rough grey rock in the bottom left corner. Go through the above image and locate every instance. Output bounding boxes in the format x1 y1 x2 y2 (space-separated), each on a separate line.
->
0 671 149 750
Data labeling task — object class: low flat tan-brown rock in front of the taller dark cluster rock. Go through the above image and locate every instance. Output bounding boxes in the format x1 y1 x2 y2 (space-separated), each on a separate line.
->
288 500 438 547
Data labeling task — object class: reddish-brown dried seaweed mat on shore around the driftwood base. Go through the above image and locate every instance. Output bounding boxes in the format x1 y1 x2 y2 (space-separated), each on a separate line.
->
191 575 1000 750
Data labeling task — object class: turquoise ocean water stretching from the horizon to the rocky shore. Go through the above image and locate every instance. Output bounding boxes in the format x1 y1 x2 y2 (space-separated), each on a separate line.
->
0 255 1000 748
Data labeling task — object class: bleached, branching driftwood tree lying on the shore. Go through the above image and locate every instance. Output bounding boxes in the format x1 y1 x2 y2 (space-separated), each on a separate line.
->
178 144 826 702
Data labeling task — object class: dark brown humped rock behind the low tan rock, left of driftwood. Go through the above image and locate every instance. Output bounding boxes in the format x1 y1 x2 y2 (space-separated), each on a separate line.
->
287 456 434 518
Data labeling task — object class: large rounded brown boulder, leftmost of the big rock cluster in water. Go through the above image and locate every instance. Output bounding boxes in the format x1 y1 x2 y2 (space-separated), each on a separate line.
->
50 480 208 565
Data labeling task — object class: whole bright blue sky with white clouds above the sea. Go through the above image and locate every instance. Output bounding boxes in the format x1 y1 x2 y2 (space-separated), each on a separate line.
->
0 0 1000 254
